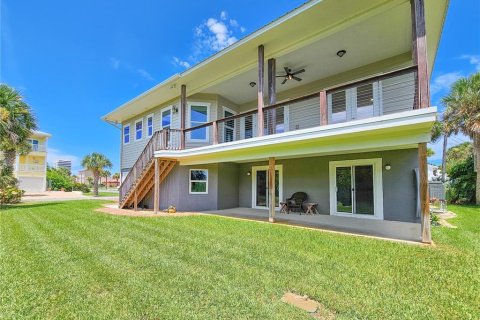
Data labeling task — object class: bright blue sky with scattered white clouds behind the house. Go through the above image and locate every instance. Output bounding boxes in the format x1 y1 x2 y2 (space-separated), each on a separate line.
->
0 0 480 173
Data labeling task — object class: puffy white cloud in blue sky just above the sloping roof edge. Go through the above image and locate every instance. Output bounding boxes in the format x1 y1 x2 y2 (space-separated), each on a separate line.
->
173 10 246 68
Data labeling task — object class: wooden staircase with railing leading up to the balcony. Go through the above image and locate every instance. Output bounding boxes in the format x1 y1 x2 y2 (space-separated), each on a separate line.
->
119 131 177 210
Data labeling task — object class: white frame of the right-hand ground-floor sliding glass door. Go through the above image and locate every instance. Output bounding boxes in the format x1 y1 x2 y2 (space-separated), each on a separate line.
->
329 158 383 220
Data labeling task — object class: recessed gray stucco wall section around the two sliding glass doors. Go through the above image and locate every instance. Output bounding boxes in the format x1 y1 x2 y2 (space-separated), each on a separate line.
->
238 149 418 222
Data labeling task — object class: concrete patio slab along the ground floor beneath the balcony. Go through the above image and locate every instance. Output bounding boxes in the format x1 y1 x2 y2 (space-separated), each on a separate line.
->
203 208 422 242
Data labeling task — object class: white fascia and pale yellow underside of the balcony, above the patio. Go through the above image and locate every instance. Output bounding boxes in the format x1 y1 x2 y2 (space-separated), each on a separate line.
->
155 107 437 165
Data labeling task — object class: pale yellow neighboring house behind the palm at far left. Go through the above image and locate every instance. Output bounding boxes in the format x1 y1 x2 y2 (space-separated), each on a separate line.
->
3 131 51 193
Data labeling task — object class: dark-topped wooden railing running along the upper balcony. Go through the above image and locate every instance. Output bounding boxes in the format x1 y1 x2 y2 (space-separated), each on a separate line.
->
178 66 418 148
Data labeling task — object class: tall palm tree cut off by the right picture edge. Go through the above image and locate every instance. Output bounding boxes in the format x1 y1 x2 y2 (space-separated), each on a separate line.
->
442 72 480 204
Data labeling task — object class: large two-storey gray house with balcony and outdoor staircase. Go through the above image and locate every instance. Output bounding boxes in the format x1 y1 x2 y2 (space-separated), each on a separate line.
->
103 0 448 242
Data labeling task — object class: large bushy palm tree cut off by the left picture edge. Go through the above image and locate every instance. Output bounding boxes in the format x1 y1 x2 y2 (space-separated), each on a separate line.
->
0 84 37 175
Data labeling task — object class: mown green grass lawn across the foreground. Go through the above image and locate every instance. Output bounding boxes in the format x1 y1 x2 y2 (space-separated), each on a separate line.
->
0 201 480 319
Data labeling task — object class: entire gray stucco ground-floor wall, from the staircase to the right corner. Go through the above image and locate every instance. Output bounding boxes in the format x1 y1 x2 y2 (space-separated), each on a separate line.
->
145 149 418 222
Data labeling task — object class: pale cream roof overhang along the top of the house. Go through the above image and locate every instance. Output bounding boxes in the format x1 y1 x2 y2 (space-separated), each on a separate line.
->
102 0 449 123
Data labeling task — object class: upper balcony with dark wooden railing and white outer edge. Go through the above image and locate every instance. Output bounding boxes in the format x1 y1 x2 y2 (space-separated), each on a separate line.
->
155 66 435 161
